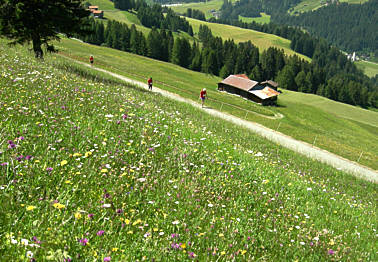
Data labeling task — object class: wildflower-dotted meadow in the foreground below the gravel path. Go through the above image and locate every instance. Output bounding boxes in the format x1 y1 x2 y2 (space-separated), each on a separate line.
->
0 40 377 261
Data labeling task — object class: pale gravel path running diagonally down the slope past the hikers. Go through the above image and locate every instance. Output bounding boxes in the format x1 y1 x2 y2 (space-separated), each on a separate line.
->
72 57 378 183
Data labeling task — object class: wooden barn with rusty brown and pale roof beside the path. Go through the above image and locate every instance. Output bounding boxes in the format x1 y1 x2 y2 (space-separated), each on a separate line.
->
218 74 280 105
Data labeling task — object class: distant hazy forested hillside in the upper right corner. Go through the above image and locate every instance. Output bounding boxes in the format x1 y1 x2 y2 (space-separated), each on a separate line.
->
272 0 378 57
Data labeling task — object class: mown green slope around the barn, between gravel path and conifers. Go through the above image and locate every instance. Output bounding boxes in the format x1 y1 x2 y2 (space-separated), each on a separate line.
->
54 40 378 169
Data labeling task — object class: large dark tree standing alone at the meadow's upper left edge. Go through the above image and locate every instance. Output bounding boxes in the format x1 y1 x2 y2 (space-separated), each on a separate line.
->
0 0 90 58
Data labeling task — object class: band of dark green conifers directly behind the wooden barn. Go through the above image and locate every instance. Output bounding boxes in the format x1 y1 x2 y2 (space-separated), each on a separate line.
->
83 19 378 107
